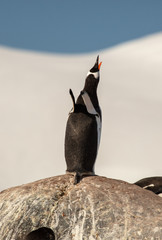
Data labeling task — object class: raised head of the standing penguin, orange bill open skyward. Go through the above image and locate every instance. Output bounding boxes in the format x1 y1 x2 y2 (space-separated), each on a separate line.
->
83 56 102 92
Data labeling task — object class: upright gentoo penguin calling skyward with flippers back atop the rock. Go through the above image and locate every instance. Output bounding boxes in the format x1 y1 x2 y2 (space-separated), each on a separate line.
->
65 56 101 184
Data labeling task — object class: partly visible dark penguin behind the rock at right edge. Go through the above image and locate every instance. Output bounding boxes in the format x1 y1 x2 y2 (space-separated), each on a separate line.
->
135 177 162 197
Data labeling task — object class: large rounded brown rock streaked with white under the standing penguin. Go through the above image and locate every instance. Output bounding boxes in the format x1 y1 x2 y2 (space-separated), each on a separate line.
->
0 175 162 240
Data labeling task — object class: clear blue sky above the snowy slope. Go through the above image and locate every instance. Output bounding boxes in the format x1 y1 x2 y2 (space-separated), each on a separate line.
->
0 0 162 53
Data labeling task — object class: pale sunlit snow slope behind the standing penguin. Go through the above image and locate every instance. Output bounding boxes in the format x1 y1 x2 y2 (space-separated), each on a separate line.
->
0 33 162 190
